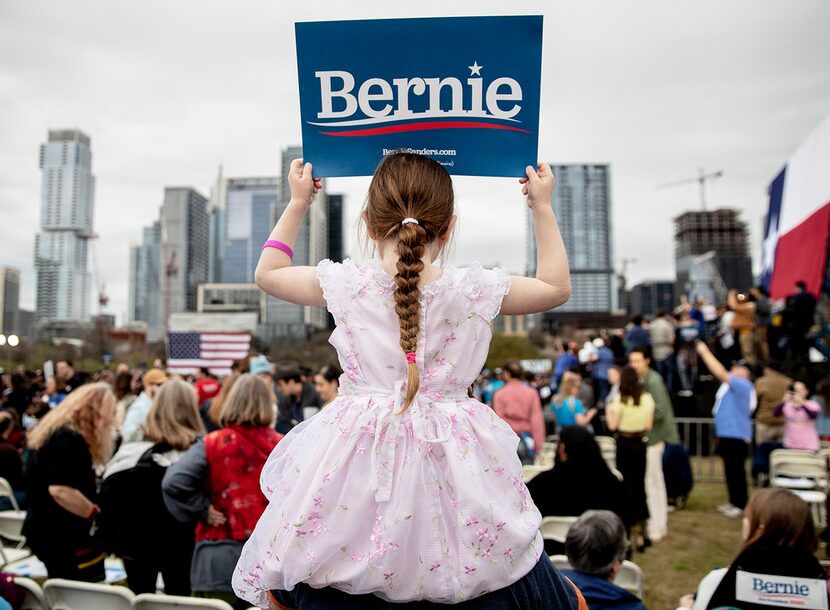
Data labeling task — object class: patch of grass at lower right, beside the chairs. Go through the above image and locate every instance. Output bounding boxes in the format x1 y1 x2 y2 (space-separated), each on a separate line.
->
632 483 741 610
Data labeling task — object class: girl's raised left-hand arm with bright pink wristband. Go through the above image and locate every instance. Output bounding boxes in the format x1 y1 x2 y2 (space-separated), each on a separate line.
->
254 159 326 307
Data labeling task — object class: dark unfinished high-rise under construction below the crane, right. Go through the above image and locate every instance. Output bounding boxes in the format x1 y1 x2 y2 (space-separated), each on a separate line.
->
674 208 752 303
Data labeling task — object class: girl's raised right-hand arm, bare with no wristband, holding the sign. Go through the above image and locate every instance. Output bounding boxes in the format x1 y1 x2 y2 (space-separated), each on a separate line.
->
501 163 571 315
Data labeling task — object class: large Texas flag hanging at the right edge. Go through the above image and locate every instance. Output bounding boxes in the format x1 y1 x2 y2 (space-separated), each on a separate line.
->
761 115 830 299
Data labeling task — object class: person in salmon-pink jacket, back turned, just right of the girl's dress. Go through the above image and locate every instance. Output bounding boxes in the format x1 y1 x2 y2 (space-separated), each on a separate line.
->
493 360 545 464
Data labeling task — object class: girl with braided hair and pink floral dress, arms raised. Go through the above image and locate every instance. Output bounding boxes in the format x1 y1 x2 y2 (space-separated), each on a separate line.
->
233 153 576 608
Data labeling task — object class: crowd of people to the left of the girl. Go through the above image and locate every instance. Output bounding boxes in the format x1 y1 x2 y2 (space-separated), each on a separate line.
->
0 356 341 608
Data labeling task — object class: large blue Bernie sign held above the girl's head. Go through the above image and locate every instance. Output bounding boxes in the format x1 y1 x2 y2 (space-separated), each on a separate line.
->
296 16 542 177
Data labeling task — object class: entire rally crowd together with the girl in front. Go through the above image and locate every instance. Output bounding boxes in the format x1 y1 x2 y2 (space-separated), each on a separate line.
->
0 148 822 610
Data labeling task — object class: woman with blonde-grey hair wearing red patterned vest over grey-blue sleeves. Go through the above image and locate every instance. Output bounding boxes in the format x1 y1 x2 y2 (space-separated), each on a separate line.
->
162 373 282 608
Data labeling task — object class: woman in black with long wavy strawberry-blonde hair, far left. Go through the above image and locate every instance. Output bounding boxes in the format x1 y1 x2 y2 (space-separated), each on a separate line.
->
23 383 116 582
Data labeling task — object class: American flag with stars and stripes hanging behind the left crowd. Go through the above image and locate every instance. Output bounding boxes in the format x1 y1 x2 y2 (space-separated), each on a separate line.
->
167 332 251 377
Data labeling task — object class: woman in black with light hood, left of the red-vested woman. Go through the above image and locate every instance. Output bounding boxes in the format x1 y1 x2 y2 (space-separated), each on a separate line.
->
99 380 205 595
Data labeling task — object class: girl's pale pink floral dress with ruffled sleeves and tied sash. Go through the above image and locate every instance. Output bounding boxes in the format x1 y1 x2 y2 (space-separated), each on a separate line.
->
233 260 542 608
